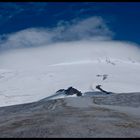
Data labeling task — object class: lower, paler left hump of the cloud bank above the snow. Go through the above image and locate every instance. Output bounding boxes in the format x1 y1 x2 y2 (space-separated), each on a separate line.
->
1 28 52 49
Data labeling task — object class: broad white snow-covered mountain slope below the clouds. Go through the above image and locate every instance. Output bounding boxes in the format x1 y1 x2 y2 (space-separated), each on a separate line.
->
0 41 140 106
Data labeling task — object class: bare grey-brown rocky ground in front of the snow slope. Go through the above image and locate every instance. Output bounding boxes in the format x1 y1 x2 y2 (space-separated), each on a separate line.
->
0 93 140 138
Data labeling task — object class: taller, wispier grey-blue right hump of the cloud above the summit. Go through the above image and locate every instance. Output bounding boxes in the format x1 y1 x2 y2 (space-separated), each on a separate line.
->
56 17 113 40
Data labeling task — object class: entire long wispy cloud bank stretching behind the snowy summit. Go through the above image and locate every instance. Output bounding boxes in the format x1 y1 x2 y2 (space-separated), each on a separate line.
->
0 17 113 49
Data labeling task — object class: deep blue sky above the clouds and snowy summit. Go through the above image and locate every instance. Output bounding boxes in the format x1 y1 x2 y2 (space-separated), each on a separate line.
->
0 2 140 44
